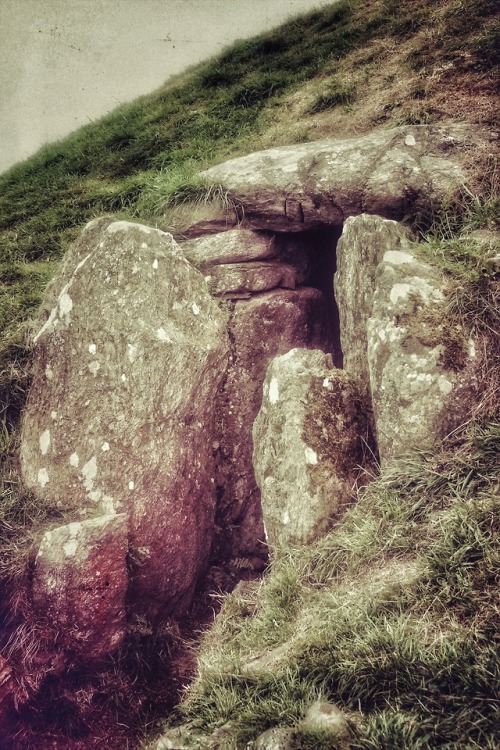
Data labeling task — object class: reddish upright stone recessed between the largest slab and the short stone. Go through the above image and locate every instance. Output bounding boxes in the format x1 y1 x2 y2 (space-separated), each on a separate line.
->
216 287 325 556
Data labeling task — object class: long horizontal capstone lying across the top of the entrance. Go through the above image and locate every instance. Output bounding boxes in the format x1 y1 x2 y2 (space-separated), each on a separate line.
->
193 125 473 234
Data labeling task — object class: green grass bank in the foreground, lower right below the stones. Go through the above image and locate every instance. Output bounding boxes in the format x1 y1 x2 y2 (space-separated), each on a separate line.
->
169 423 500 750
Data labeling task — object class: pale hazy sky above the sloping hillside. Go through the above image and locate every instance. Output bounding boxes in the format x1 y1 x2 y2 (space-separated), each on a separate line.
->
0 0 332 172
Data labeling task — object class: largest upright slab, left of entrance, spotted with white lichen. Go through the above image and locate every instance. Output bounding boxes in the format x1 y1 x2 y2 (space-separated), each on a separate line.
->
21 220 228 619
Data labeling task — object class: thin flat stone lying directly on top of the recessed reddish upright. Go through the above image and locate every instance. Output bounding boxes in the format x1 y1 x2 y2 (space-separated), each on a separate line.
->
205 262 296 298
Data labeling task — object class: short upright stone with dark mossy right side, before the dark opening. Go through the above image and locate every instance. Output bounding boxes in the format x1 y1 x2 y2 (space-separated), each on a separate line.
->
253 349 364 546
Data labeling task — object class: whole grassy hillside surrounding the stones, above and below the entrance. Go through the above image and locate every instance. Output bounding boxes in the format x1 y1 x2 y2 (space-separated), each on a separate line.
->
0 0 499 750
